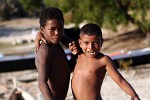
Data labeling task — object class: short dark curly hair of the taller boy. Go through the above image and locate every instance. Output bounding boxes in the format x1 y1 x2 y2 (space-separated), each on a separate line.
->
39 7 64 27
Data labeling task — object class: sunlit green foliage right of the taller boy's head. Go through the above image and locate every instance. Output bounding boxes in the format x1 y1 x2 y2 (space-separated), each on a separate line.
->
42 0 150 33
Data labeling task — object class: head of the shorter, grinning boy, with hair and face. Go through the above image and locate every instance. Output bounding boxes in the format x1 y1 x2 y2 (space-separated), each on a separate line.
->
79 23 103 57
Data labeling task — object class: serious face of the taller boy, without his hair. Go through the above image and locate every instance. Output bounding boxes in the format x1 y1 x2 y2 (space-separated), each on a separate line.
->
41 19 64 44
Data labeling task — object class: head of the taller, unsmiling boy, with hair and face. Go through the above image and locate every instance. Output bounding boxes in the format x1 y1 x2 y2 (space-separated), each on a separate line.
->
39 7 64 44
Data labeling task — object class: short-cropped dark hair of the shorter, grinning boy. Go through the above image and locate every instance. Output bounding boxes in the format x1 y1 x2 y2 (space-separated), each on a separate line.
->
80 23 102 38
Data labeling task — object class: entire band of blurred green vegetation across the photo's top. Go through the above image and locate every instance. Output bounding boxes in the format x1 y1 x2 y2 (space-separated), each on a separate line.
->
0 0 150 33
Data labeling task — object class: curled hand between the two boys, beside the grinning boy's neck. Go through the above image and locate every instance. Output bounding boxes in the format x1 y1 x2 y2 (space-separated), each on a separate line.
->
69 41 80 55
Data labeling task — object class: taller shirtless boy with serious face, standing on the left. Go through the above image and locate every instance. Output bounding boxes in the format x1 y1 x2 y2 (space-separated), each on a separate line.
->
35 7 77 100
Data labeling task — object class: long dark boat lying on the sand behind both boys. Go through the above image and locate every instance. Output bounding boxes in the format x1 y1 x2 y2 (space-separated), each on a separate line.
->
0 47 150 72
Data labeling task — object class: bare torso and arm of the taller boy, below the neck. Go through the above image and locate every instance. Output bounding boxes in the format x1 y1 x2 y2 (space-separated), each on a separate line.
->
36 43 70 100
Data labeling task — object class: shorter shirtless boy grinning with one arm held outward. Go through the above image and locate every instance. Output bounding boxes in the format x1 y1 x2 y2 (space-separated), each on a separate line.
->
72 23 140 100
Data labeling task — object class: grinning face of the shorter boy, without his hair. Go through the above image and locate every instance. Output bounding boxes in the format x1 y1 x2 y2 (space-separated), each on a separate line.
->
79 34 102 57
